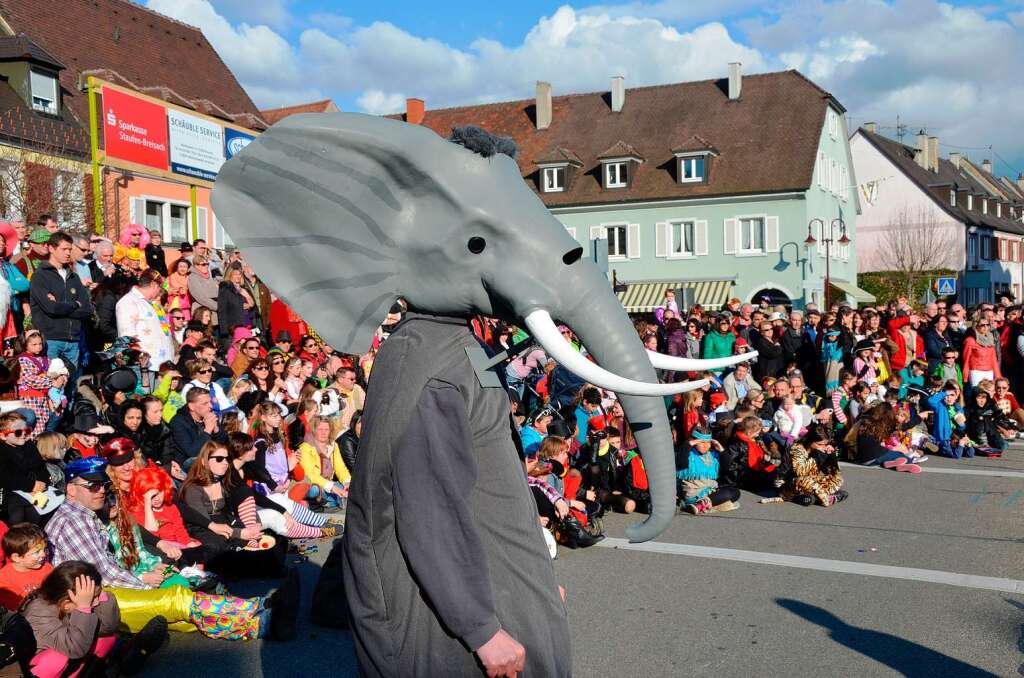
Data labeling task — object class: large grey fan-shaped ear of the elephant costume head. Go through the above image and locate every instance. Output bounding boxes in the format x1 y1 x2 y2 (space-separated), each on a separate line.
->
212 113 453 353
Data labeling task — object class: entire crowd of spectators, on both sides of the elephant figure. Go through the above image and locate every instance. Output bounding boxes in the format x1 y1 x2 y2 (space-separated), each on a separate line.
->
0 215 1024 677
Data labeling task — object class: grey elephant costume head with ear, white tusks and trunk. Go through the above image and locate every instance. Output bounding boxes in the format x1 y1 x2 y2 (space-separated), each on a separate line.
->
213 113 751 541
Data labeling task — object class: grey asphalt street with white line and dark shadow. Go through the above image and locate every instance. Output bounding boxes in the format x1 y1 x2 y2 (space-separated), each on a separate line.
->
145 443 1024 678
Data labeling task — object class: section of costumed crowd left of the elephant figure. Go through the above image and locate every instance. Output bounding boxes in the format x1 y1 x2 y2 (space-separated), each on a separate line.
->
0 215 364 677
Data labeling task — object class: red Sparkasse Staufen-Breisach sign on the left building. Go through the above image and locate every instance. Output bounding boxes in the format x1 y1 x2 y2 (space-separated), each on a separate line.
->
103 89 167 170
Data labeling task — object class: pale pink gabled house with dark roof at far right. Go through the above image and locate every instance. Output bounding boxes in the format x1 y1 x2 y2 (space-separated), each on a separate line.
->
850 123 1024 304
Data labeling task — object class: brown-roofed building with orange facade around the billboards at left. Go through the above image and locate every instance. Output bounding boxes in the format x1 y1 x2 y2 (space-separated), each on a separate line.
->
0 0 268 246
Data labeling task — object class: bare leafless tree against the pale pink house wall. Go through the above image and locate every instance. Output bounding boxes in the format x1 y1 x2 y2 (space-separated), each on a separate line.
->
873 208 964 297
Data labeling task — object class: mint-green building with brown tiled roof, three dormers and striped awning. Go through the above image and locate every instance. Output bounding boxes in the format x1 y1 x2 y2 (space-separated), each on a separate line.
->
396 63 870 312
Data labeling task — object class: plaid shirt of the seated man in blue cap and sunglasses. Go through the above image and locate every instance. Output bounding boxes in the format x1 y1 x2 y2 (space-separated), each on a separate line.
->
46 500 152 589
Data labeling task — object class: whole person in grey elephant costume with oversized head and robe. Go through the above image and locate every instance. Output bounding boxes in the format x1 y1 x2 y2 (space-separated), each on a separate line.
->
213 113 751 678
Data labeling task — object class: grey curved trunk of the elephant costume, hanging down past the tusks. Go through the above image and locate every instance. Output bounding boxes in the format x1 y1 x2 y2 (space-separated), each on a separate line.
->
555 283 676 542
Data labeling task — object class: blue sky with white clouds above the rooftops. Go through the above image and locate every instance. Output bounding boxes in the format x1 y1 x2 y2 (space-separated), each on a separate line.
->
146 0 1024 177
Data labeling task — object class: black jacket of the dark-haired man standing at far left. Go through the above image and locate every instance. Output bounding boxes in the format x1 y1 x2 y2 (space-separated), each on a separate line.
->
29 261 92 342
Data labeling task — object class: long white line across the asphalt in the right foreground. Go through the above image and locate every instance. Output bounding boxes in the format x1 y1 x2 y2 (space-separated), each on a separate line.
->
598 537 1024 594
